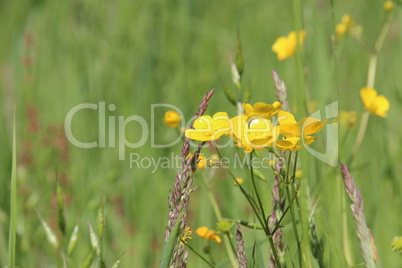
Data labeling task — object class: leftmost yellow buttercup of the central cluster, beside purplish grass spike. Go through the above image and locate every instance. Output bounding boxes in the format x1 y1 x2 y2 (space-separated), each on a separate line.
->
185 112 230 141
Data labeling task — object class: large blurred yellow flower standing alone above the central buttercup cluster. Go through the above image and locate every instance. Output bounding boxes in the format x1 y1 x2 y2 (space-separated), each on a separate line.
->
272 30 306 60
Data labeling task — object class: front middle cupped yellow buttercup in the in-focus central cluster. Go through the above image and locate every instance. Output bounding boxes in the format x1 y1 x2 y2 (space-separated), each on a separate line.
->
231 115 279 153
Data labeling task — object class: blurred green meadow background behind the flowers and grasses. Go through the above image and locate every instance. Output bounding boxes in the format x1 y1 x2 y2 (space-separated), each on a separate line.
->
0 0 402 267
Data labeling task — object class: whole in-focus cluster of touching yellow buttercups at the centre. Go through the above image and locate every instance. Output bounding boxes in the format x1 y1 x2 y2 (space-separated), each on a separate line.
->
185 102 327 153
